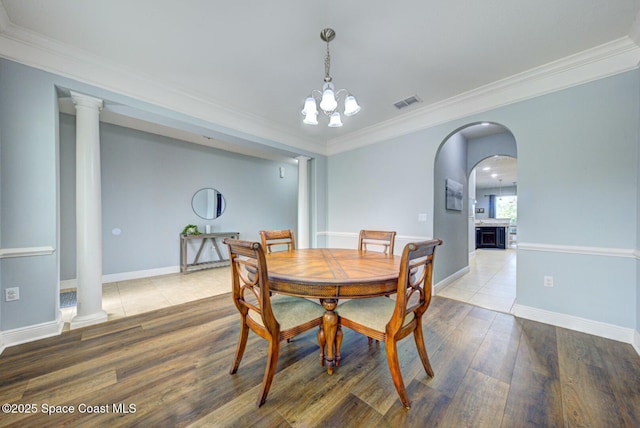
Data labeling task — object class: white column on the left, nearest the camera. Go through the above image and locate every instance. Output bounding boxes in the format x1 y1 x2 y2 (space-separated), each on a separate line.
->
71 92 107 328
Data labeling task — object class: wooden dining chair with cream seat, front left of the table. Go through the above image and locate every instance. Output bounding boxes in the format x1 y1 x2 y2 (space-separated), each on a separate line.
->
224 238 324 407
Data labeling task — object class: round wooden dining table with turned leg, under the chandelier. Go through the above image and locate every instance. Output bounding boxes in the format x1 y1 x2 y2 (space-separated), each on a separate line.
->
266 248 401 374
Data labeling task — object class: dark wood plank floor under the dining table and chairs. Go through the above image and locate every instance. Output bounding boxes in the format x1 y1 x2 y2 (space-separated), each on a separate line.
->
0 294 640 428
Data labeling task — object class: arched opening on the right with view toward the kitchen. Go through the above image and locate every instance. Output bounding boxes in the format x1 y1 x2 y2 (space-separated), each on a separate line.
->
434 122 517 312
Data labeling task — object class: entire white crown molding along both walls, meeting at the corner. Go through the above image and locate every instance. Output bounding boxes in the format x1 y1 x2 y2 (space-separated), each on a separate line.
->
0 7 640 156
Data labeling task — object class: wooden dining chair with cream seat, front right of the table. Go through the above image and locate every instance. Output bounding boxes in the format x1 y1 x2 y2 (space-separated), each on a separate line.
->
337 239 442 409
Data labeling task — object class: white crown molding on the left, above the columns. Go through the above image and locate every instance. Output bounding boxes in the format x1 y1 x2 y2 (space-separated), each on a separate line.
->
0 16 326 155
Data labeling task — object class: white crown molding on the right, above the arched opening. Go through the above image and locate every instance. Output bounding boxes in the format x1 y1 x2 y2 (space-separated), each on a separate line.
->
327 37 640 155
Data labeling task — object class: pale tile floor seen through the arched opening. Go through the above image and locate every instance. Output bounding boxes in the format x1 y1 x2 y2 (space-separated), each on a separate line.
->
437 248 516 312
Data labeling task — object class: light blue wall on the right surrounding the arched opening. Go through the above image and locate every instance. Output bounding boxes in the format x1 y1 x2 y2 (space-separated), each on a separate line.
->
328 71 640 327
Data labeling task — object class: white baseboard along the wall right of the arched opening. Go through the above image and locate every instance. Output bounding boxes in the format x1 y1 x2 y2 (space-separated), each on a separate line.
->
511 303 640 355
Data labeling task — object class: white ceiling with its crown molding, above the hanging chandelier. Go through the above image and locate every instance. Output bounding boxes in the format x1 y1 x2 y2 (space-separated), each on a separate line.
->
0 0 640 159
